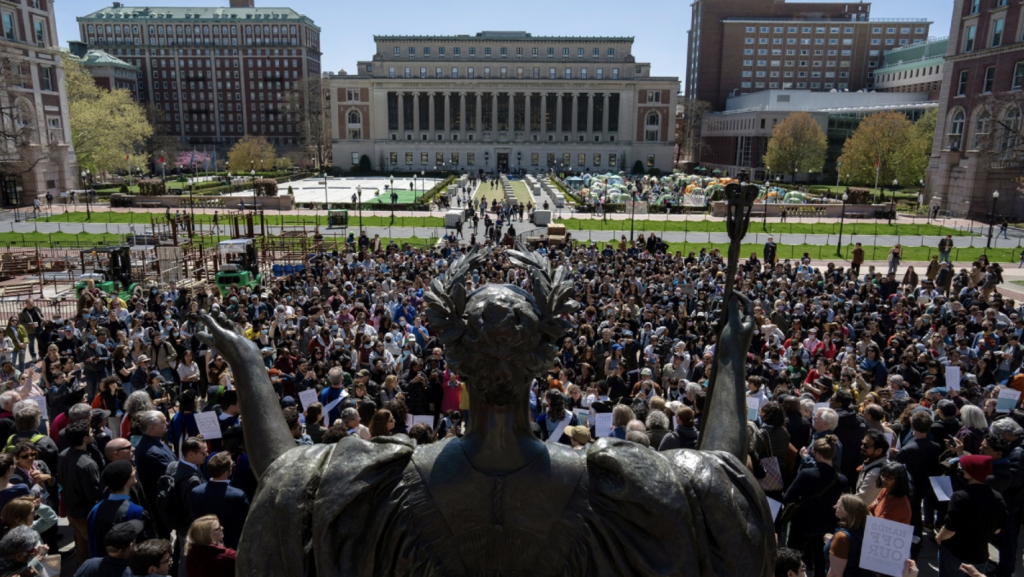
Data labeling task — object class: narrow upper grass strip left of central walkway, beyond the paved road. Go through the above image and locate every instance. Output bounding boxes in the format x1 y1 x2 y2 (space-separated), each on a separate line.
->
36 209 444 228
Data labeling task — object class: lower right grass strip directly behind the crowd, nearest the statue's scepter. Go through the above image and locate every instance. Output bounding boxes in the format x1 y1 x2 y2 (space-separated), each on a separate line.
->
655 243 1020 264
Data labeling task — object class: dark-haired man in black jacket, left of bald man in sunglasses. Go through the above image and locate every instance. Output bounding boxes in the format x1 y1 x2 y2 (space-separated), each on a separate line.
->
57 420 103 565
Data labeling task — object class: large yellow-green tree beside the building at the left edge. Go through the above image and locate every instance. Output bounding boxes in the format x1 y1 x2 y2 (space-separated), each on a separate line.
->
65 58 153 174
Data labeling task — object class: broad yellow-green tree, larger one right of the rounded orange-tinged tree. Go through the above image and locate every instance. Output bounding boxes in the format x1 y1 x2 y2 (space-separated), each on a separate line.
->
843 111 921 191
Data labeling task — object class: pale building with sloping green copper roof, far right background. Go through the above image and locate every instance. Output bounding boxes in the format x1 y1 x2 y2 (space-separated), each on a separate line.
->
874 38 949 100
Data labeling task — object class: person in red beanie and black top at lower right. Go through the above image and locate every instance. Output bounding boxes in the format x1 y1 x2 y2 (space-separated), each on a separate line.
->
935 455 1007 577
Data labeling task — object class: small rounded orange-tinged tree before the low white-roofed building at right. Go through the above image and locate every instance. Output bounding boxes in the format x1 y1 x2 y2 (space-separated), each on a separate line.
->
764 112 828 181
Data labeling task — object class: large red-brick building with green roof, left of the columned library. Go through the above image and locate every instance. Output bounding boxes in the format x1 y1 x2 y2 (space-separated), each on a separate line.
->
78 0 322 150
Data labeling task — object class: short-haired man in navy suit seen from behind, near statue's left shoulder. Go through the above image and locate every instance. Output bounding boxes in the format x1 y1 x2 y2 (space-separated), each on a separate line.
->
189 451 249 549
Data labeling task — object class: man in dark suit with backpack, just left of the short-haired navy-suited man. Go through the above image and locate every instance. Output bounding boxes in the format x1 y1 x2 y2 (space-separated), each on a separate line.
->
156 437 210 567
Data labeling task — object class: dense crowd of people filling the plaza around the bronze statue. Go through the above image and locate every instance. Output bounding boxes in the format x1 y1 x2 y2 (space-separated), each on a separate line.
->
0 214 1024 577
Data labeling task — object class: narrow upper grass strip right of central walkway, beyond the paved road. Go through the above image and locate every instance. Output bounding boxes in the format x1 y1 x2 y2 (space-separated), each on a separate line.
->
558 218 970 237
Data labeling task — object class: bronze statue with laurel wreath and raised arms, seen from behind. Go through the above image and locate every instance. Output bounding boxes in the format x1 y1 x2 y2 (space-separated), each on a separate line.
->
201 184 775 577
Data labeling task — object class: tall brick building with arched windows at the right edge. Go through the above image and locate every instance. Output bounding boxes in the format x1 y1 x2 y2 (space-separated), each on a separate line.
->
926 0 1024 219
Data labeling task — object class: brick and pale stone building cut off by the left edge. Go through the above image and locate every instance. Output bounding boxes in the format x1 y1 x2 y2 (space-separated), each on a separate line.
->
0 0 79 207
